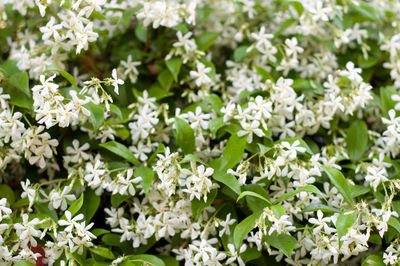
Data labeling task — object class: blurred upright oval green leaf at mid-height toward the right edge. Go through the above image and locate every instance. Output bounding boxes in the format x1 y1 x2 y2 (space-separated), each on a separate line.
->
346 120 368 161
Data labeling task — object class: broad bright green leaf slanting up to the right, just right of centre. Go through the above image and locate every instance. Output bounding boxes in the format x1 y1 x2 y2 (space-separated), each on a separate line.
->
209 134 247 172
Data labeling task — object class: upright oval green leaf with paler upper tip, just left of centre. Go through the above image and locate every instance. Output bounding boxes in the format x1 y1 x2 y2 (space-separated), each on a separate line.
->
175 117 195 154
